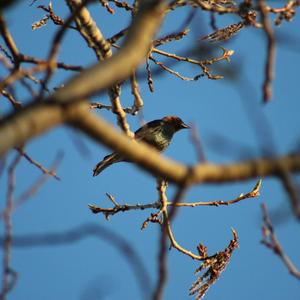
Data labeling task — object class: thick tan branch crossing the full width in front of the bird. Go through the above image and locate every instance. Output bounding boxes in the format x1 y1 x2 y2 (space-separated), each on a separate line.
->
0 98 300 184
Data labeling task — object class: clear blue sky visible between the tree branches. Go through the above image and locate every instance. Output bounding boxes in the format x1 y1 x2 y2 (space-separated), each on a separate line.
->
0 1 300 300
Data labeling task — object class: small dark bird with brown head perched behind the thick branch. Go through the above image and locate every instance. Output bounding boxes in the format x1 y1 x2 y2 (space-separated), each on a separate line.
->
93 116 190 176
